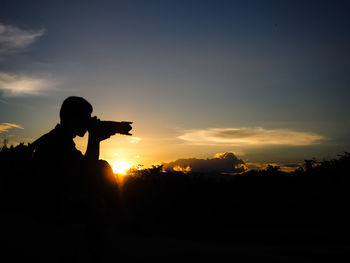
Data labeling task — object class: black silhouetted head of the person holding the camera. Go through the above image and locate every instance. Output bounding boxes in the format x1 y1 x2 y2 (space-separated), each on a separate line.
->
60 96 93 137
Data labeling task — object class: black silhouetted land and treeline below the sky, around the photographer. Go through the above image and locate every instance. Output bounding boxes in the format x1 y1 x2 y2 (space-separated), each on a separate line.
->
0 148 350 262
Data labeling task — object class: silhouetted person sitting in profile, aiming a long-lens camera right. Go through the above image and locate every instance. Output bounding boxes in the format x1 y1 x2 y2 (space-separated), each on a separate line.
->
33 97 131 225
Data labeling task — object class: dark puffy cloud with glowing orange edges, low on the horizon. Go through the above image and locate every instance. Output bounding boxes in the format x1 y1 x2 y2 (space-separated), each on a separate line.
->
163 152 245 173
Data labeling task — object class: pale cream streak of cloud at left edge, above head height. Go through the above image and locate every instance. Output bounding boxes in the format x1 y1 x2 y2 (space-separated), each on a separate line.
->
0 72 51 97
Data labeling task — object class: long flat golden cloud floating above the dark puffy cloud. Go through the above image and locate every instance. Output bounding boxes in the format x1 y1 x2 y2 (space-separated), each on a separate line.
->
177 127 325 146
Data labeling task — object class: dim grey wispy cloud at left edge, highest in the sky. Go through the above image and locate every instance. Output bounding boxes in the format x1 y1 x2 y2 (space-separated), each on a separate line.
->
0 23 45 54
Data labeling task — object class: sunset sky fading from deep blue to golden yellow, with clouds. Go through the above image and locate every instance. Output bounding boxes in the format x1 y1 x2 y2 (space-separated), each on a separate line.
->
0 0 350 170
